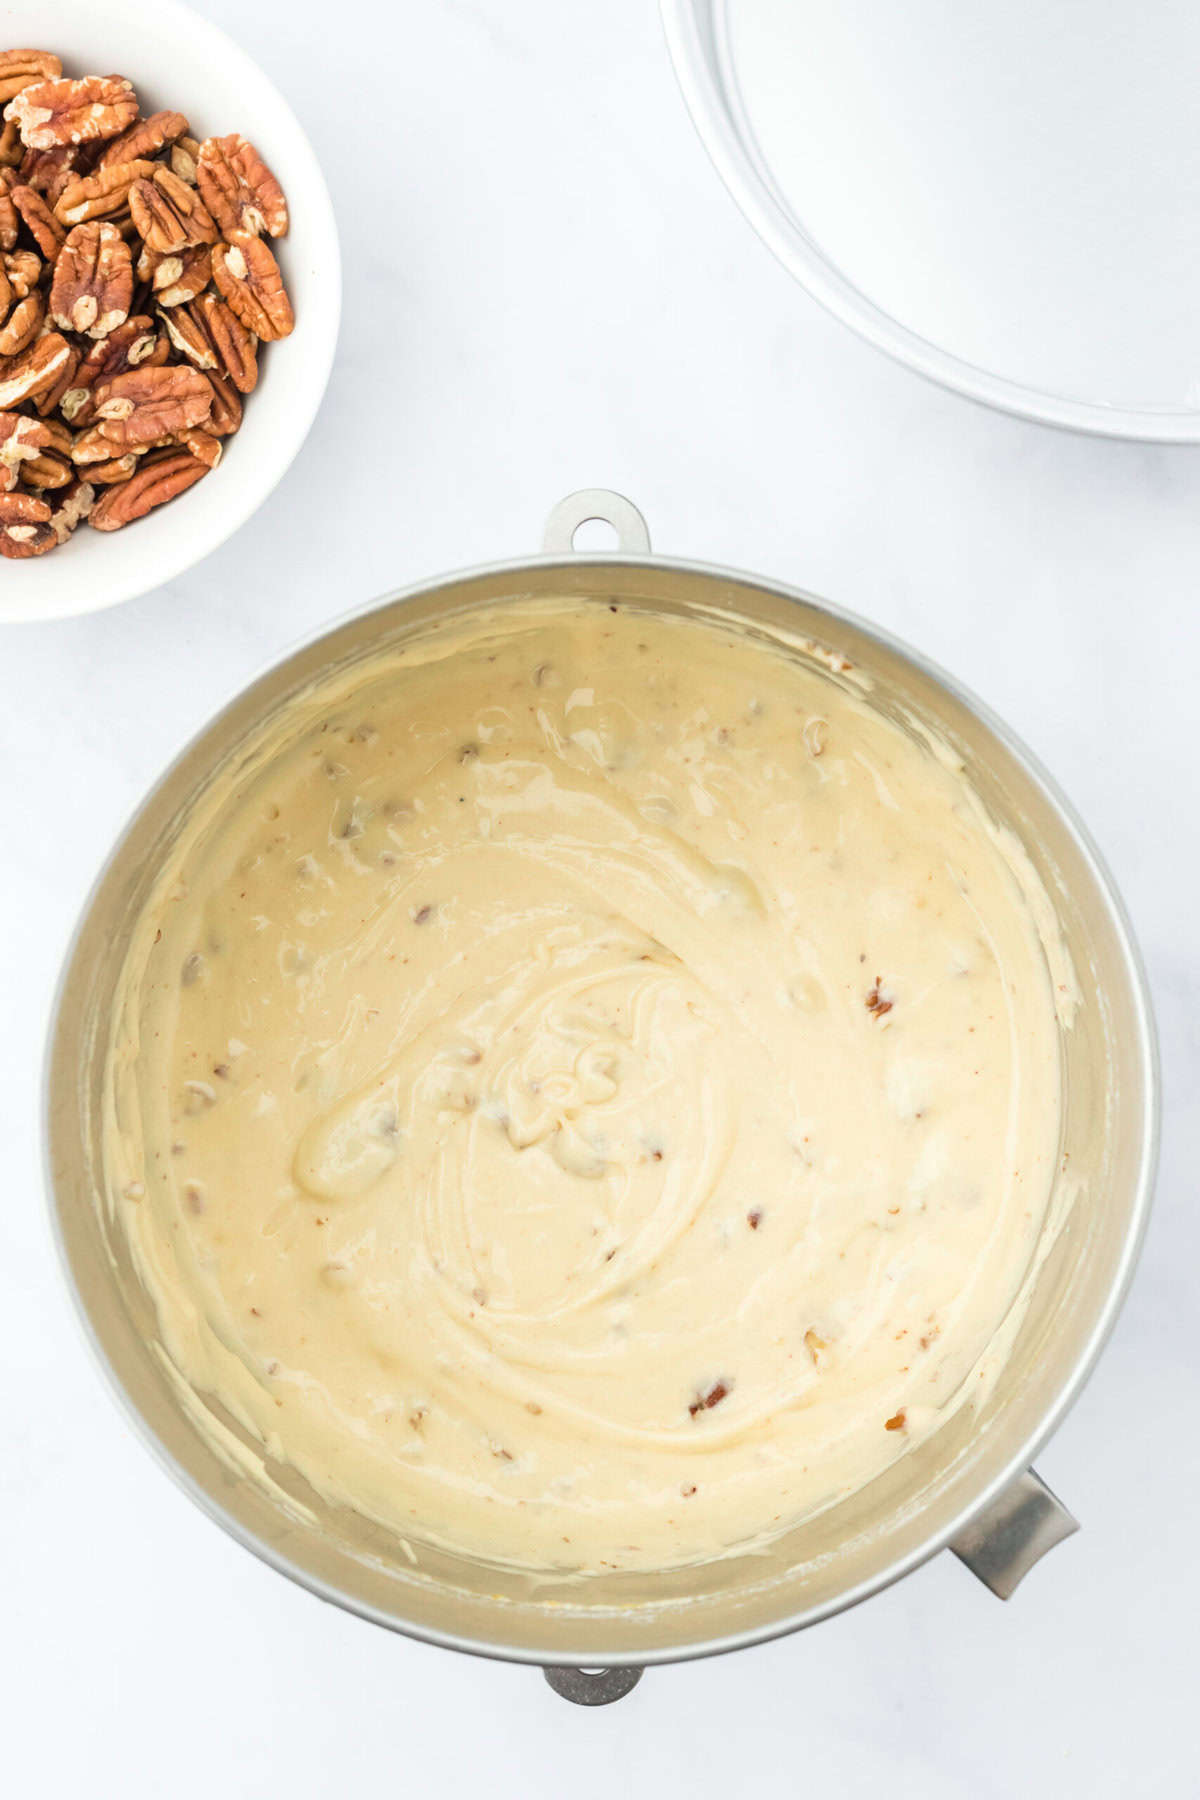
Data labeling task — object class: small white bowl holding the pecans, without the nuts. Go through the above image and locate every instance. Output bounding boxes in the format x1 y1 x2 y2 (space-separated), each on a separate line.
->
0 0 342 621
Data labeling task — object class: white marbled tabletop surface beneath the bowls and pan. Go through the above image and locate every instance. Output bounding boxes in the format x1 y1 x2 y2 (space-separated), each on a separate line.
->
0 0 1200 1800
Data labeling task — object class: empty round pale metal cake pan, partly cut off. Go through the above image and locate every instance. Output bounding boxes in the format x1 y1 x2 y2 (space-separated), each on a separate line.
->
660 0 1200 443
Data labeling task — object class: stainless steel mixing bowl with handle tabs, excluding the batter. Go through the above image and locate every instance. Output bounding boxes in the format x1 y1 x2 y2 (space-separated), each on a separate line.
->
47 490 1159 1703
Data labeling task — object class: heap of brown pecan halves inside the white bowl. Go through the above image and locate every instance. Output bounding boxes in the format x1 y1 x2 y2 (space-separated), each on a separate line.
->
0 50 293 558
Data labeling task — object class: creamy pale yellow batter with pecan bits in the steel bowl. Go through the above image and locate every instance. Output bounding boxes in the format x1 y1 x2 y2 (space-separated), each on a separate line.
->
106 603 1060 1570
